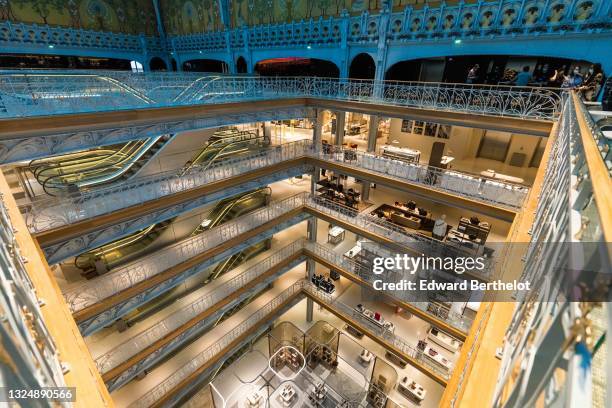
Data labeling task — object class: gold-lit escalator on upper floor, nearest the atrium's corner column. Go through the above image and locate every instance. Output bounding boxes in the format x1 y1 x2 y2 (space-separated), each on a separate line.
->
182 128 268 174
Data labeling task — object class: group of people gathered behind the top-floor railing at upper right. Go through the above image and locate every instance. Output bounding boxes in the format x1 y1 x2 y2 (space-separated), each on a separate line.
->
466 64 605 101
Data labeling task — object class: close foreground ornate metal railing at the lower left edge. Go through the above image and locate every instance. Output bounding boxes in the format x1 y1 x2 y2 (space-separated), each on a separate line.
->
0 196 66 398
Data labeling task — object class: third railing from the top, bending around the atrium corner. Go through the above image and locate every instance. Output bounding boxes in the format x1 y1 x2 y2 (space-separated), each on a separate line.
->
64 193 495 330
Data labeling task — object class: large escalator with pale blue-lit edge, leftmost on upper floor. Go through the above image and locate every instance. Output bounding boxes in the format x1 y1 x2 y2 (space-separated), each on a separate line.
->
28 135 173 196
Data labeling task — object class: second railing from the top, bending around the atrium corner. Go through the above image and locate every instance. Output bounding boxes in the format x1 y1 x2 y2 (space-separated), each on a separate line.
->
25 140 529 237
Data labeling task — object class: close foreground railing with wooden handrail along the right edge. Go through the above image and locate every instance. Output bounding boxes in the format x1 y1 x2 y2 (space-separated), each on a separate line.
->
494 95 612 407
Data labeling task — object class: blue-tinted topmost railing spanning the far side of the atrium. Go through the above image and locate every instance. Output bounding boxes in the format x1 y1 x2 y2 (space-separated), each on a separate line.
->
0 71 560 120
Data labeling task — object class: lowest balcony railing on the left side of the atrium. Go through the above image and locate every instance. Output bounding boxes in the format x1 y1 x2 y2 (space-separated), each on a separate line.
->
129 281 304 408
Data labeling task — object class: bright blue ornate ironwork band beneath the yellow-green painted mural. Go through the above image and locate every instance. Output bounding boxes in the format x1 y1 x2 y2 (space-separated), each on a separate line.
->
0 0 610 60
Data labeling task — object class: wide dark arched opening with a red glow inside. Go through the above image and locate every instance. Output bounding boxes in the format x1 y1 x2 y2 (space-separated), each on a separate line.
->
255 57 340 78
